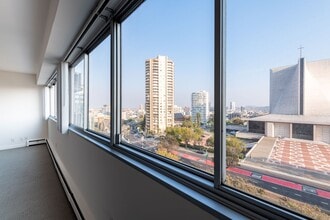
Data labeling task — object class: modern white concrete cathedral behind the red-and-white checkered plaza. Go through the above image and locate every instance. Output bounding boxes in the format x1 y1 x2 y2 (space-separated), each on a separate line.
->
249 58 330 143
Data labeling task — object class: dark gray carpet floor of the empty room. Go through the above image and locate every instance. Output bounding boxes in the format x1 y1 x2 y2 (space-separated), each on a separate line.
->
0 145 76 220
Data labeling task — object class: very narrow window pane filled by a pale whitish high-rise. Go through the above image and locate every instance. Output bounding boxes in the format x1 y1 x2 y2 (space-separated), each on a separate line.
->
71 60 85 128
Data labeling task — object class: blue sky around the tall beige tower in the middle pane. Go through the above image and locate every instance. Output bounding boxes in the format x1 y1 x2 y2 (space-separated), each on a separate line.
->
122 0 214 108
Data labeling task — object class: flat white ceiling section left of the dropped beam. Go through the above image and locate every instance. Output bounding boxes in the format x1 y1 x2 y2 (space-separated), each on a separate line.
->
0 0 50 73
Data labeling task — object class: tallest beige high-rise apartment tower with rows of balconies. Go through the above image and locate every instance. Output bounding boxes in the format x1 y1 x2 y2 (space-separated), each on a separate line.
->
145 56 174 134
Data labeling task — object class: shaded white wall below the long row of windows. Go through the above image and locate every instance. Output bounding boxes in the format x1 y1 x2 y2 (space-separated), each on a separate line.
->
48 120 215 220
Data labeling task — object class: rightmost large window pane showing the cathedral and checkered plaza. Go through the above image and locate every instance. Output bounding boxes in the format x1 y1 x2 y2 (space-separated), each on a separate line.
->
225 0 330 219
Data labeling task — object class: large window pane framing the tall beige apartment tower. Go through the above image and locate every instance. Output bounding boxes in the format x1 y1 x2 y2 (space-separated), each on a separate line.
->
122 0 214 174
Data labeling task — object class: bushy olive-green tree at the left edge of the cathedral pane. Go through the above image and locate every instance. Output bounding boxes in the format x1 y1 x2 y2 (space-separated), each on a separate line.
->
226 137 244 166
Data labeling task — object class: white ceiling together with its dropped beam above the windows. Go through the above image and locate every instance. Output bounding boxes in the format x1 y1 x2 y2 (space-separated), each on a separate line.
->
0 0 99 85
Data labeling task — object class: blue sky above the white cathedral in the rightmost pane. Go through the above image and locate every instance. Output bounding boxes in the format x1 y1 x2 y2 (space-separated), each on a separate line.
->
226 0 330 106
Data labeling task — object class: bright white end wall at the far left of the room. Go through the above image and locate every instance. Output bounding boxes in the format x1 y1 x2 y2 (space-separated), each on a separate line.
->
0 71 48 150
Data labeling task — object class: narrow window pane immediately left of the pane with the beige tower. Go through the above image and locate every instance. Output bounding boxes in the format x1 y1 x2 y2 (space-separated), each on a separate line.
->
88 36 110 136
